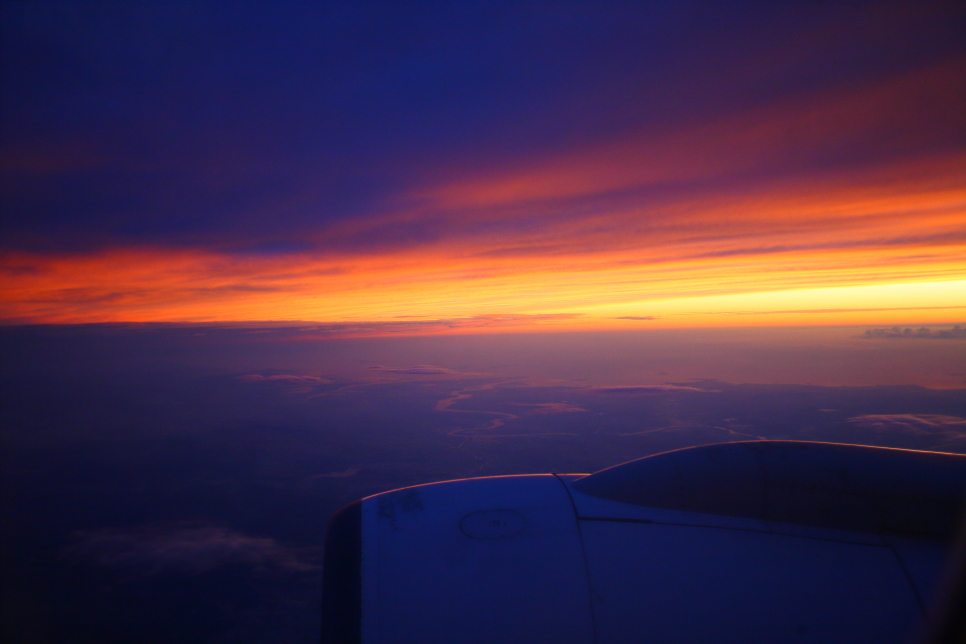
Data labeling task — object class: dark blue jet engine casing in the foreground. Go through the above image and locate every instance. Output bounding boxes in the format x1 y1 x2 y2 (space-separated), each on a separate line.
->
323 441 966 644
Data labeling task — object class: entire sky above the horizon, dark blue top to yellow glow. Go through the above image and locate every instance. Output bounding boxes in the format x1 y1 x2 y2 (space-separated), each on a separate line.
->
0 1 966 335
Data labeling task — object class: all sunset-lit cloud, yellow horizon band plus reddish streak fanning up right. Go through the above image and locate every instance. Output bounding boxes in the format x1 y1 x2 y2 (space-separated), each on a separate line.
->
0 60 966 333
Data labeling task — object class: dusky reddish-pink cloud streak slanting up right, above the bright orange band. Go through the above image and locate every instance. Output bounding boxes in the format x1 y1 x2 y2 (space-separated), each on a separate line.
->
426 59 966 207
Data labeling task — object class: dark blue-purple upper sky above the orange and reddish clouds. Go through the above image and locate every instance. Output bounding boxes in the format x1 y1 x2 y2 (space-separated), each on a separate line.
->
2 2 966 251
